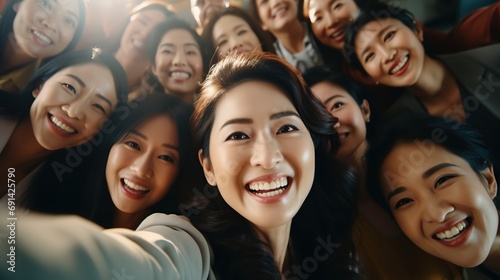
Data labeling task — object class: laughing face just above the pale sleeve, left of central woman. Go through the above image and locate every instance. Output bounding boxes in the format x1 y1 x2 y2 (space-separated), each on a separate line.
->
106 112 180 213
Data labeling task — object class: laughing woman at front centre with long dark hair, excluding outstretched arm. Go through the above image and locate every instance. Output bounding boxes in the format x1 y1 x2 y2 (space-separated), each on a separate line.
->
190 53 355 279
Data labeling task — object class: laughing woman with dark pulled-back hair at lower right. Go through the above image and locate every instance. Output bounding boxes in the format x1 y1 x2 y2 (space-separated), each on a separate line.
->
367 117 500 279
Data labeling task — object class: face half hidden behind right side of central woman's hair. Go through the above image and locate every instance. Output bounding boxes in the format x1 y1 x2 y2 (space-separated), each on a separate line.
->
311 81 370 160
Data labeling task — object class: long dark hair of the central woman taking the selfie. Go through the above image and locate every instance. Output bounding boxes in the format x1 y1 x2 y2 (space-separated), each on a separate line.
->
188 53 356 279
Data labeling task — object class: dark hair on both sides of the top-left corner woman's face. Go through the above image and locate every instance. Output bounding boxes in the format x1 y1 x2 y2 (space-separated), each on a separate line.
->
0 0 86 64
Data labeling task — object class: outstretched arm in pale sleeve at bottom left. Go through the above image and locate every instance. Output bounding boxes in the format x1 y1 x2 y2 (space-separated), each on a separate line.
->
0 214 213 280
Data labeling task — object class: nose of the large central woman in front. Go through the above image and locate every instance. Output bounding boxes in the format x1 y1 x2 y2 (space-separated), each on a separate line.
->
250 136 283 169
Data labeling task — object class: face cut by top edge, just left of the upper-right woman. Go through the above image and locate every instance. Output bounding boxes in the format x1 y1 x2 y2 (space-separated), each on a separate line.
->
308 0 359 50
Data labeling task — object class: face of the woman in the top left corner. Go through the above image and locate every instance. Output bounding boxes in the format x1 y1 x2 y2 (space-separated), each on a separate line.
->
13 0 81 58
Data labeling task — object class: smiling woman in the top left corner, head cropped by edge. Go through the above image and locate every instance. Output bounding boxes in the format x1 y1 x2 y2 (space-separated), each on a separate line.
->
0 0 85 92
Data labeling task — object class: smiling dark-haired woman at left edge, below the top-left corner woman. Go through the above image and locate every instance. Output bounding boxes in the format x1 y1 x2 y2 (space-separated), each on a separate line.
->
0 49 127 208
